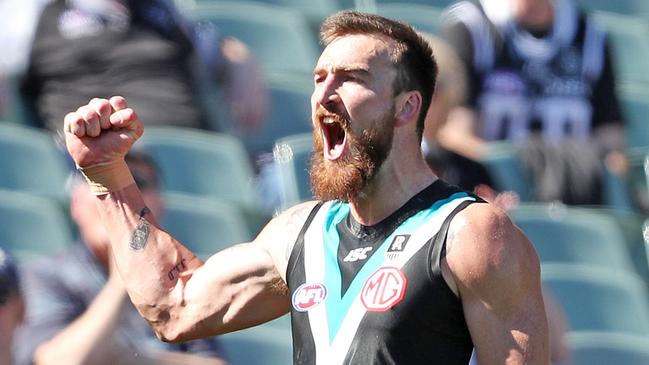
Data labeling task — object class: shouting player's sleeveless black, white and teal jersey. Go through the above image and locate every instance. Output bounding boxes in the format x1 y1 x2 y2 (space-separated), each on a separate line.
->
287 180 478 365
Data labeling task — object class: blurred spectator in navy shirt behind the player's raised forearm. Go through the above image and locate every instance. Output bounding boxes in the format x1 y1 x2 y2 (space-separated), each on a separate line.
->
10 154 230 365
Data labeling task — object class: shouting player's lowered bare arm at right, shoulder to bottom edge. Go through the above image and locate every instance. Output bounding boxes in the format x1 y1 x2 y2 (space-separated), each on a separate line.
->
442 204 549 365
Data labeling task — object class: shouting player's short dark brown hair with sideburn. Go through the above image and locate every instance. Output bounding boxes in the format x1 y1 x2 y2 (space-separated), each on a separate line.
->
320 11 437 138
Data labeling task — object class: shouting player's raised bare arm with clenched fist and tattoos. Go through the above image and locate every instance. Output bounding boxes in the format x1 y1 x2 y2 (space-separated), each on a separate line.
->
65 97 308 341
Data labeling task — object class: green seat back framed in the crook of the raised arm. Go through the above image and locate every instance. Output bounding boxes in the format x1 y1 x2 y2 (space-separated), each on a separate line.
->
161 193 253 260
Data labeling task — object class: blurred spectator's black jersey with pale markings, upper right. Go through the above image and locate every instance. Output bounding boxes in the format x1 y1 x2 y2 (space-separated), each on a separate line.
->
446 0 621 142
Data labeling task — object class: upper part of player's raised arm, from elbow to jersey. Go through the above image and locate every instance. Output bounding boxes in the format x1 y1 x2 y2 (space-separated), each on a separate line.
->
168 199 314 338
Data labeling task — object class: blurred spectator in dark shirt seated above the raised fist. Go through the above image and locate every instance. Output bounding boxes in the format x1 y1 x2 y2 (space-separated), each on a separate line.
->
23 0 267 131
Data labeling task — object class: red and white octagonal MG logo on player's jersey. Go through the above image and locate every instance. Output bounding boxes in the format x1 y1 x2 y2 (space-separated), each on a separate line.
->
361 267 408 312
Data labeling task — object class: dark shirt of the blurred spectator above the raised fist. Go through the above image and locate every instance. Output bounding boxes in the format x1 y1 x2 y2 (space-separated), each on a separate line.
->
24 0 208 131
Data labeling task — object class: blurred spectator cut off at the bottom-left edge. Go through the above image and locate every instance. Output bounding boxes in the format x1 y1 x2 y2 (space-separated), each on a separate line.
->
0 247 25 365
